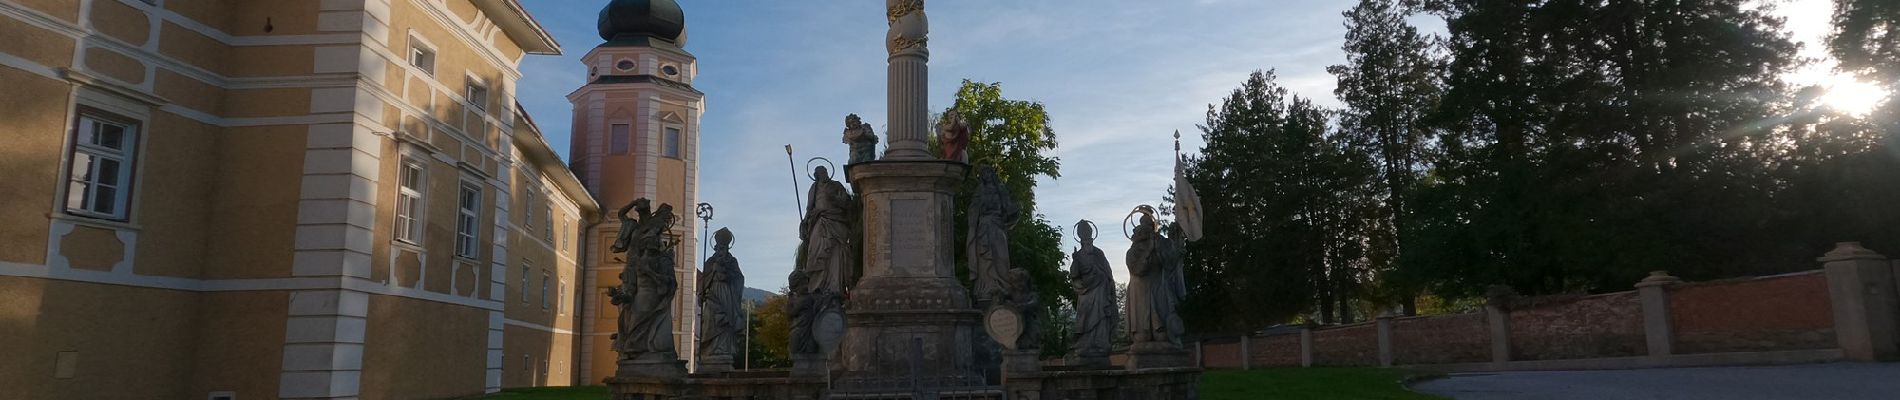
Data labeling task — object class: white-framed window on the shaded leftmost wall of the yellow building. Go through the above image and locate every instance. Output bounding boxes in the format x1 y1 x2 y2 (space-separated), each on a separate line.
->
67 108 139 220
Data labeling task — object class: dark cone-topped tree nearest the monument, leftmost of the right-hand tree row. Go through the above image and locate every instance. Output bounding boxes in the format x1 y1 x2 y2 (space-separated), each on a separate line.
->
1182 72 1355 332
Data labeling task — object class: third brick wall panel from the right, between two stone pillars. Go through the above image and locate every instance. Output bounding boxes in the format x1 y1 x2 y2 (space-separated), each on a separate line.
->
1393 313 1492 366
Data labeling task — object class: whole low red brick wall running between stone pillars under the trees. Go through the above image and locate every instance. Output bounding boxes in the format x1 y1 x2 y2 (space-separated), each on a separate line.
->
1203 265 1869 368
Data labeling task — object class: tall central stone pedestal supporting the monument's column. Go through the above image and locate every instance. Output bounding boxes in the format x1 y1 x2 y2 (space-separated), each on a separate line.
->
840 159 984 391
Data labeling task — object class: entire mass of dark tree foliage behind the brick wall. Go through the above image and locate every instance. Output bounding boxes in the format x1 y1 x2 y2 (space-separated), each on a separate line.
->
1165 0 1900 332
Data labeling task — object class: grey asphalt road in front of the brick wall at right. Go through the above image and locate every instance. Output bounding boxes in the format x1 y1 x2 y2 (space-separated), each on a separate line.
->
1412 362 1900 400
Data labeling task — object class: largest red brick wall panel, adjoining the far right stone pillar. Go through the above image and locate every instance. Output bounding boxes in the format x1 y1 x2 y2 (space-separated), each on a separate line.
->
1668 271 1837 353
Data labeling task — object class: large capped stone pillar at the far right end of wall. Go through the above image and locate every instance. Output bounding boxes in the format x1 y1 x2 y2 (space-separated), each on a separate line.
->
1818 243 1900 362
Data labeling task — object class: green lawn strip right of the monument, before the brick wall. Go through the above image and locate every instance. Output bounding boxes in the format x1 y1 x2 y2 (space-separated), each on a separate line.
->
1201 368 1444 400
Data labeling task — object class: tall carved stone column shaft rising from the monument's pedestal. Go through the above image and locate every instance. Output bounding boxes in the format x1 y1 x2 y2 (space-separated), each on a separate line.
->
884 0 935 159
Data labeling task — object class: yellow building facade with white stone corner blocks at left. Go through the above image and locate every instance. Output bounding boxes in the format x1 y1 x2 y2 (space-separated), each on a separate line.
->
0 0 602 400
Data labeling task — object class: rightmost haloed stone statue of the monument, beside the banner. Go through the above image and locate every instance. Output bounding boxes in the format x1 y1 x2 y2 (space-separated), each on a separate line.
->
1127 214 1188 349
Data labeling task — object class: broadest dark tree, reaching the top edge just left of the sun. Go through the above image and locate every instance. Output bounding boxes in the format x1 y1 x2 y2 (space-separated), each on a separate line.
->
1408 0 1796 296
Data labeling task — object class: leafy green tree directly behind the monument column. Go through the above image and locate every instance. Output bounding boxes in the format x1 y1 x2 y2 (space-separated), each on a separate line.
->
931 80 1075 356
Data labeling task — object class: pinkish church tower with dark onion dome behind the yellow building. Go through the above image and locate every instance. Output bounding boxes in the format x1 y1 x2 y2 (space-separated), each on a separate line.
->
568 0 705 383
